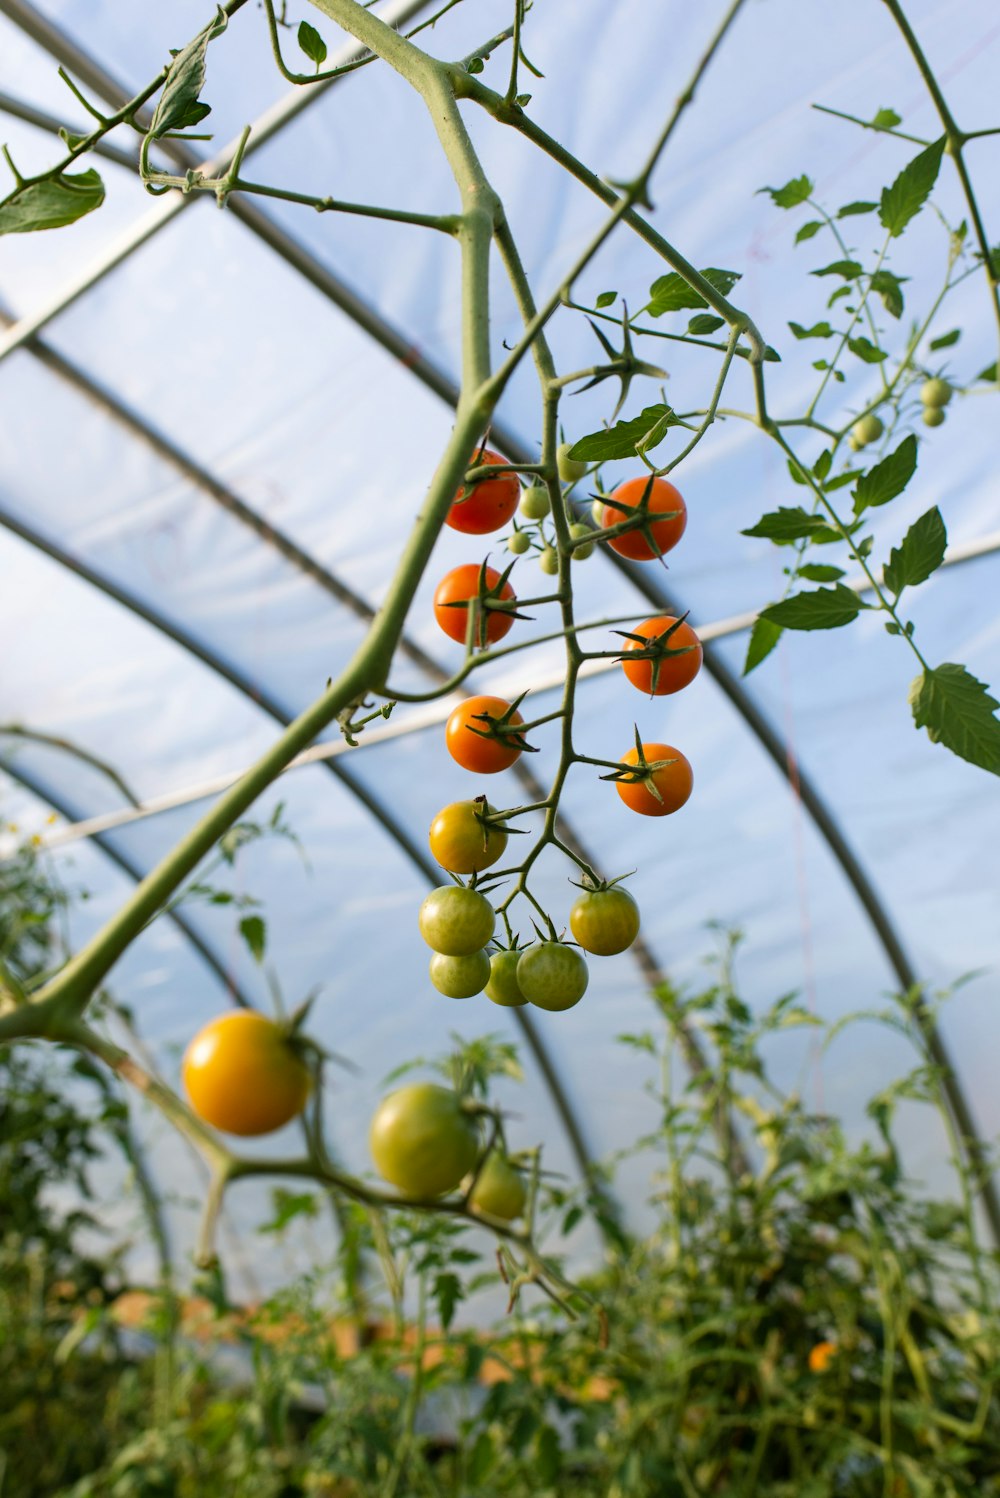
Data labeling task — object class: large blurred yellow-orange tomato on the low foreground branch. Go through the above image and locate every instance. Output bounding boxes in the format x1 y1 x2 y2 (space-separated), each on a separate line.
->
181 1010 311 1135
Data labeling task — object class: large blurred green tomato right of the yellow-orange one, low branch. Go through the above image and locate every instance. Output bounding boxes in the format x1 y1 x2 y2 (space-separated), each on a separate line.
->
368 1082 479 1197
